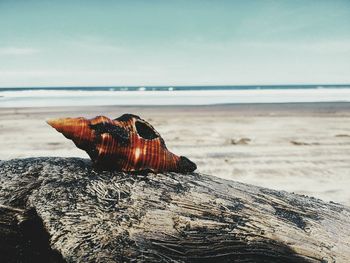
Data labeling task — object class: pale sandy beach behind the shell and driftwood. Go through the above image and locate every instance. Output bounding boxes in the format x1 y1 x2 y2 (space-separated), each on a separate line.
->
0 103 350 205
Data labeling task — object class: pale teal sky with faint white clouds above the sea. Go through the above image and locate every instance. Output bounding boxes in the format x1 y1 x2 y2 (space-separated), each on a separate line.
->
0 0 350 87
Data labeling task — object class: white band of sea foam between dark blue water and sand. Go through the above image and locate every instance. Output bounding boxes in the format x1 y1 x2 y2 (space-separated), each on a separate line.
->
0 88 350 107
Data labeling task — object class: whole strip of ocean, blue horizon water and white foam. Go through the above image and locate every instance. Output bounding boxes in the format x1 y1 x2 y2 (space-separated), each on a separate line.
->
0 84 350 108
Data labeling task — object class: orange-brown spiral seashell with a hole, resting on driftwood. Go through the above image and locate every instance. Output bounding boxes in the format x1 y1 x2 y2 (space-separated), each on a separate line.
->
47 114 197 172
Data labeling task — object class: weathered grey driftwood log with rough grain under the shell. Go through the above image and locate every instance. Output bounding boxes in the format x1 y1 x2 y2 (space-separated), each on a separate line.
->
0 158 350 262
